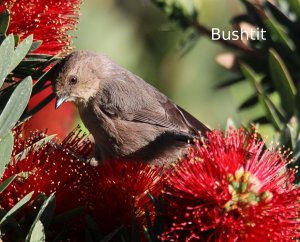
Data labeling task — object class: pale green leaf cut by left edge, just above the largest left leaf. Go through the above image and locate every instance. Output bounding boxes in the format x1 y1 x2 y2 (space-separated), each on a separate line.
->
0 34 15 87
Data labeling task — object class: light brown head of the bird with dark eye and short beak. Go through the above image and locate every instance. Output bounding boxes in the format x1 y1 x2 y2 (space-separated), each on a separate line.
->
53 51 115 108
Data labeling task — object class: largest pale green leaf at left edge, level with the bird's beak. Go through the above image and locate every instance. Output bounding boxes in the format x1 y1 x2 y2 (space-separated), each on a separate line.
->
0 77 32 138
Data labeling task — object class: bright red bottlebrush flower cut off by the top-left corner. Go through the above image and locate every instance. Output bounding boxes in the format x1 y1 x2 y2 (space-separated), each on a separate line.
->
0 0 81 55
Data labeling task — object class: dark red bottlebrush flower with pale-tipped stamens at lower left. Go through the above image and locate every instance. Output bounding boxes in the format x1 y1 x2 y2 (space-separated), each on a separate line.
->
0 126 97 212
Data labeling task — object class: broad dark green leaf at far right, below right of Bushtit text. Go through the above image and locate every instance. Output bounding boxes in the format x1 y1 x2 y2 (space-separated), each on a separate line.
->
269 49 297 117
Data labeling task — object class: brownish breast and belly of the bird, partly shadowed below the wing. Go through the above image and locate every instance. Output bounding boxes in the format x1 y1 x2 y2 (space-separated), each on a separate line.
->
79 102 185 161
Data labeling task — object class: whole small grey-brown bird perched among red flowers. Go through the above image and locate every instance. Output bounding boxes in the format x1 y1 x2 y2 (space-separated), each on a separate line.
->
53 51 209 163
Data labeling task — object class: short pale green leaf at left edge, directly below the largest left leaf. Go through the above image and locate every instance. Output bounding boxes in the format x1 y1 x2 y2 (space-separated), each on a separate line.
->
0 132 14 177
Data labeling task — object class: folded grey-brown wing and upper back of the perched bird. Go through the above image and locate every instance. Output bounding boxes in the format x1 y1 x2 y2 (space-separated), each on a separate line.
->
101 73 209 135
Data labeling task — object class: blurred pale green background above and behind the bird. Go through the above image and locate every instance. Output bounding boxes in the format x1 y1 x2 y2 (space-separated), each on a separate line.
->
74 0 260 128
